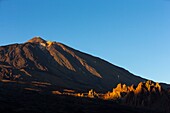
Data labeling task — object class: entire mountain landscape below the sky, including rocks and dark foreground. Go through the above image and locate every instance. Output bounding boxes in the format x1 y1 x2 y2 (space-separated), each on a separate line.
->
0 37 170 113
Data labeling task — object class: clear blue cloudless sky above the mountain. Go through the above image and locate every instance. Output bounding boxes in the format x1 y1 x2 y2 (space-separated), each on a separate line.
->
0 0 170 83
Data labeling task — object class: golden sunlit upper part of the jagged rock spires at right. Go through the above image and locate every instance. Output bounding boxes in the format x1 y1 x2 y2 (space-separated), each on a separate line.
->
104 80 164 100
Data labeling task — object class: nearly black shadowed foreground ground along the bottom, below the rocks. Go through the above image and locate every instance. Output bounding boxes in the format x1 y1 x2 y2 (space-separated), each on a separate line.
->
0 81 163 113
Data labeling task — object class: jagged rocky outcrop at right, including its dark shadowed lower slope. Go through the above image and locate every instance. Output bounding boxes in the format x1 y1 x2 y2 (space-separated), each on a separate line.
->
104 81 170 113
